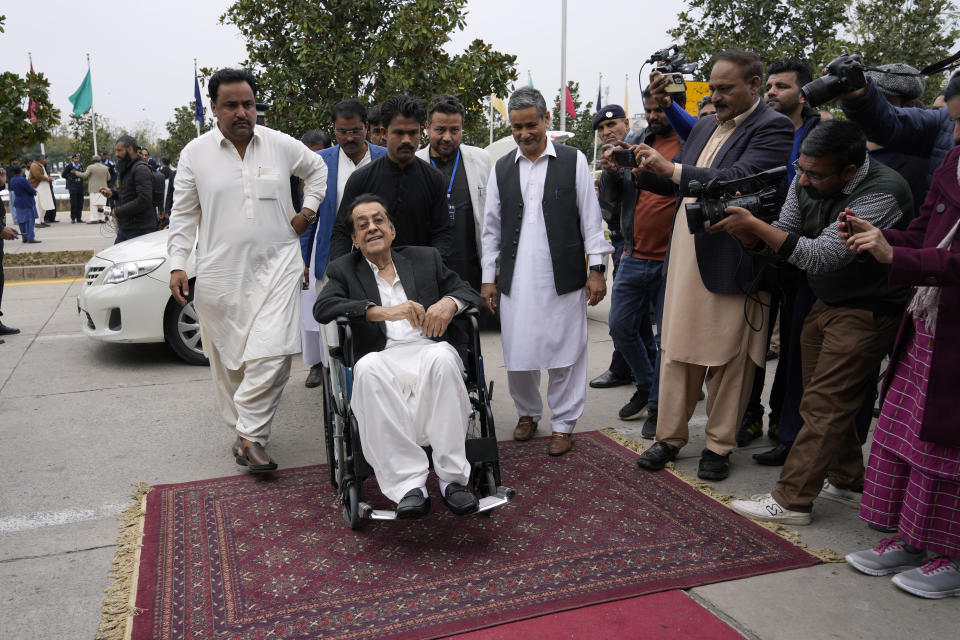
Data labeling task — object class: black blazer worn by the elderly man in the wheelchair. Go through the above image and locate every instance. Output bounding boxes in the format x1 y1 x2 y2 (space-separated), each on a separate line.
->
313 246 482 360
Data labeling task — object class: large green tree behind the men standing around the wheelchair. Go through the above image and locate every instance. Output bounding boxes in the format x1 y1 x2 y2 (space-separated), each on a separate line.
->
219 0 517 137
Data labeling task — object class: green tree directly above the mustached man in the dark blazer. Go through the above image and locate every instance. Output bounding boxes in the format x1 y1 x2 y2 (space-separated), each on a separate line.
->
668 0 848 80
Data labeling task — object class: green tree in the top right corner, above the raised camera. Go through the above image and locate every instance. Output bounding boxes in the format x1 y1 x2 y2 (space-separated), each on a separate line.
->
850 0 960 104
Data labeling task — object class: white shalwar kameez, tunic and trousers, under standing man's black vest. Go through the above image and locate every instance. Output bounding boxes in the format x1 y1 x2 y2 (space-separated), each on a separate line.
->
481 140 613 433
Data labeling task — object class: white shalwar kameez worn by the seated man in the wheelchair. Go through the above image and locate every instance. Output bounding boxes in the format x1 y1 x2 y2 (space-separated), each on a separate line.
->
350 261 470 502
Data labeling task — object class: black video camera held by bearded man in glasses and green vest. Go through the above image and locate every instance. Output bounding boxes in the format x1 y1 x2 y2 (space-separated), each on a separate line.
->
687 167 787 233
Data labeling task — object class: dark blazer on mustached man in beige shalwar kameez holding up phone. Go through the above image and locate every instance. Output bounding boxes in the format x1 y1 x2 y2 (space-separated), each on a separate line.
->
637 100 795 293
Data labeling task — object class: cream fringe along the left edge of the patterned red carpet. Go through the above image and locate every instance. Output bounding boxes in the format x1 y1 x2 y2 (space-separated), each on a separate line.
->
96 482 151 640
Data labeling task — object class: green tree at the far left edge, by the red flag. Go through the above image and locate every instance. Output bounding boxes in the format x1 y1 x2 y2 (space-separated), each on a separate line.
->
0 65 60 160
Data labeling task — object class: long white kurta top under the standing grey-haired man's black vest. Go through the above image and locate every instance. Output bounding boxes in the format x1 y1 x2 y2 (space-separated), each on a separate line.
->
481 140 613 371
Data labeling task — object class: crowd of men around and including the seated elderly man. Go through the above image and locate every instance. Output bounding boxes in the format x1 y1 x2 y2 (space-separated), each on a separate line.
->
3 51 960 596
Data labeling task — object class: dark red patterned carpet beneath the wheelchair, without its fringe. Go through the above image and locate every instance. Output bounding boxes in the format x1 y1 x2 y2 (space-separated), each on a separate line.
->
132 432 818 640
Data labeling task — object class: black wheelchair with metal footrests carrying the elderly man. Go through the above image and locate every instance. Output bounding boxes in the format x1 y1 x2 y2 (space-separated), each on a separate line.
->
321 308 515 530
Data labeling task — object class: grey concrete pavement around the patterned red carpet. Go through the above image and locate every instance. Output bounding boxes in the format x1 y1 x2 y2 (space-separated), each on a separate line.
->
0 280 960 640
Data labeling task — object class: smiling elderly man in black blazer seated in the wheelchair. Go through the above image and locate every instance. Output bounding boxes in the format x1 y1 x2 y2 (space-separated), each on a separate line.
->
314 194 481 518
